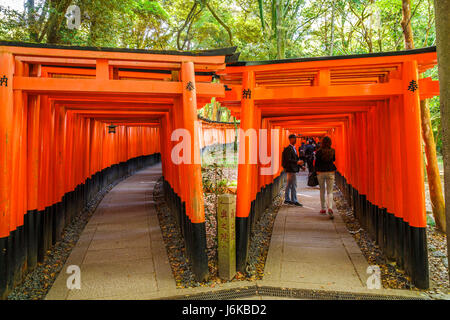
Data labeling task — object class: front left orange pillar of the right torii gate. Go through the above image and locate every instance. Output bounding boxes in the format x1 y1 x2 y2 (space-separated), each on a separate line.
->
236 71 257 272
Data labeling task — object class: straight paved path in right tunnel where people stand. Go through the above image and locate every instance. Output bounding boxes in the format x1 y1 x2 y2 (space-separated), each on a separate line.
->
264 173 368 291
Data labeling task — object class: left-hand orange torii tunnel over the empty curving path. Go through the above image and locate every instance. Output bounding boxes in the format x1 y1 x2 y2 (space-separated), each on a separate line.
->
0 42 239 297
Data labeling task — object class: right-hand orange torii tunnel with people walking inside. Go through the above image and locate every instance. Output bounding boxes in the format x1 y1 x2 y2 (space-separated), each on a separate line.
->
219 48 439 288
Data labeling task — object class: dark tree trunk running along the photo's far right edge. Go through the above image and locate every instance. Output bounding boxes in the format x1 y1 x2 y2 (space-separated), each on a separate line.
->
434 0 450 284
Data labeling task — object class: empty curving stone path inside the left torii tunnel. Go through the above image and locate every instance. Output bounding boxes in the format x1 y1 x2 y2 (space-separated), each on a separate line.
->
46 165 175 299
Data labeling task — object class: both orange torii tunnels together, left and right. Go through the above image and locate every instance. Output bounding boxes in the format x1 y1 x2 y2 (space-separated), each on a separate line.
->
0 42 439 296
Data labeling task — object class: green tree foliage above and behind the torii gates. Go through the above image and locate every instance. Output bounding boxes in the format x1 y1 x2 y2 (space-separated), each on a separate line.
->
0 0 442 151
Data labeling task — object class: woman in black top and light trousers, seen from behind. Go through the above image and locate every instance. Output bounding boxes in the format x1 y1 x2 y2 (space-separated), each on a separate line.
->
315 136 336 219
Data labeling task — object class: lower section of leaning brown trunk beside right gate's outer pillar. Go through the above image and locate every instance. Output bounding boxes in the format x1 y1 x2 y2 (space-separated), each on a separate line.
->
420 99 446 232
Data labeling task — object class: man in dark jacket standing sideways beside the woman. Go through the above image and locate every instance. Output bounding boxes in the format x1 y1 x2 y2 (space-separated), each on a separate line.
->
281 134 303 207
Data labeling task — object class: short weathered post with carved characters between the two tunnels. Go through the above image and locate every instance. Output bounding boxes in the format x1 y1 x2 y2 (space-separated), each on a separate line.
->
217 194 236 280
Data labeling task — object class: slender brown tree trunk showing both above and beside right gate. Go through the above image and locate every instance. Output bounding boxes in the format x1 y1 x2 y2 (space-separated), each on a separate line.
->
402 0 446 232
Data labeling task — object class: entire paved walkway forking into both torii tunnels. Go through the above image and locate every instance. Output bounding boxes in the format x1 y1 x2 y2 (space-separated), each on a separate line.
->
46 165 424 300
